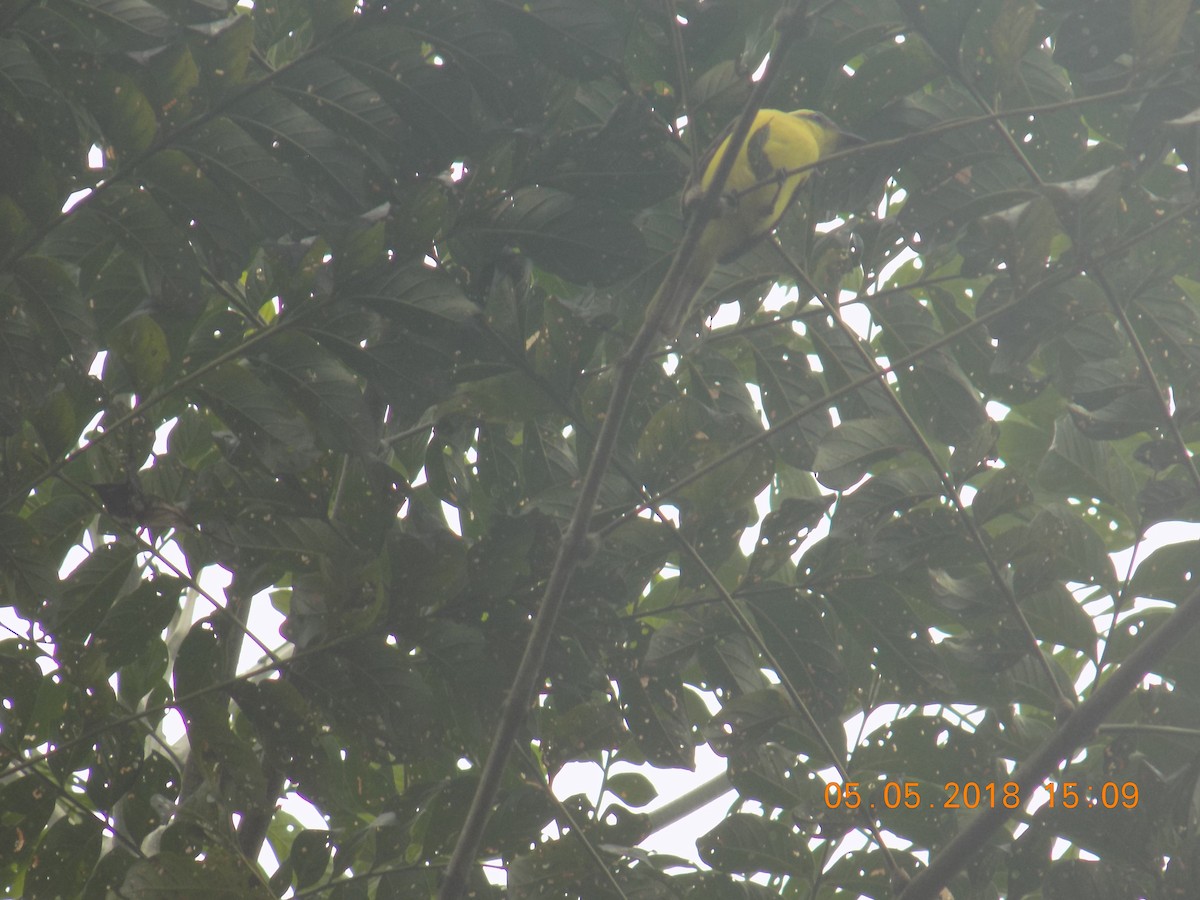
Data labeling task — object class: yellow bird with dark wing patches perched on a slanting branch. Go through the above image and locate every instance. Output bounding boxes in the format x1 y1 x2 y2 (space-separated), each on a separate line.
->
652 109 859 337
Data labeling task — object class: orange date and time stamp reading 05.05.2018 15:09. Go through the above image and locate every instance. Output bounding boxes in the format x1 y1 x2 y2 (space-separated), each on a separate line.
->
824 781 1139 810
